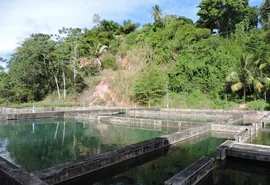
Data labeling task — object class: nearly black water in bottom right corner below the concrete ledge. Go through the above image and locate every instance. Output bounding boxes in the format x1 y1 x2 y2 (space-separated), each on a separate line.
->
198 157 270 185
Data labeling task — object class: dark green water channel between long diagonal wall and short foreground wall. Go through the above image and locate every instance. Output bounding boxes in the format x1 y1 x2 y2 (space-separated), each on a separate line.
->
61 132 226 185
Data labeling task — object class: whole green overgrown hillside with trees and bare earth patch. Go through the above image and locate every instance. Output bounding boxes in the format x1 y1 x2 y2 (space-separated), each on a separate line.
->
0 0 270 109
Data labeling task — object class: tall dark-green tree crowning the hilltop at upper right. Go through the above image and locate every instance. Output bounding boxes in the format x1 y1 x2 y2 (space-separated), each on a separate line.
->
197 0 258 34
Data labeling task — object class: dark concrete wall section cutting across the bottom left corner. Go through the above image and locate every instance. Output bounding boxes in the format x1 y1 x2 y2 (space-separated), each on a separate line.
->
0 157 47 185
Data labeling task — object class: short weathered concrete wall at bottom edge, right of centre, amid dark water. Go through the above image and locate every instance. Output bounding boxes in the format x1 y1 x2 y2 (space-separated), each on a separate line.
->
164 156 214 185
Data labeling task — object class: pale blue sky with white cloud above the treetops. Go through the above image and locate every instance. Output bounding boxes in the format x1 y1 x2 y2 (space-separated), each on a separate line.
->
0 0 263 65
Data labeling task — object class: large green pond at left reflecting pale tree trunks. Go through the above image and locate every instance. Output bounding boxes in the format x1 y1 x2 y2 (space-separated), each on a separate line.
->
0 118 175 172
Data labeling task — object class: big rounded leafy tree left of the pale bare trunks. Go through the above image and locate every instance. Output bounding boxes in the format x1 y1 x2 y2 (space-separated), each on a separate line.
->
8 33 55 102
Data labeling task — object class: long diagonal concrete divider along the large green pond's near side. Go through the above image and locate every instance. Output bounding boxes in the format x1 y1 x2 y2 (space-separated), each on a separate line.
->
36 126 211 184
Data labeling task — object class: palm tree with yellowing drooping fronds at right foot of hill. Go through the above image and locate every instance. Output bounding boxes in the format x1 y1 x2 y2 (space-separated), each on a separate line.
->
226 55 270 99
